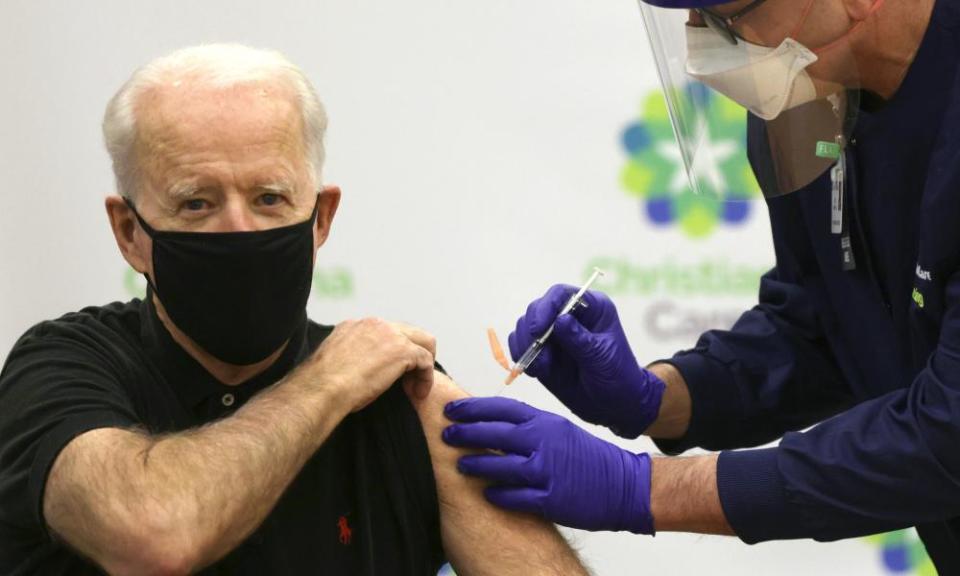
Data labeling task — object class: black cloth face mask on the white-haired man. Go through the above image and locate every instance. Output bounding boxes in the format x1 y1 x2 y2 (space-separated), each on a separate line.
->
127 198 319 365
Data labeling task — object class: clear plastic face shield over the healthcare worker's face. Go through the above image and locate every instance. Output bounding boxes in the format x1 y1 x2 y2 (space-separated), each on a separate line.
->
639 0 859 197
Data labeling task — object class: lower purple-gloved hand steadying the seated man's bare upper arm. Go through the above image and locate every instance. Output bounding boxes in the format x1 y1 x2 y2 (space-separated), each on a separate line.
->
443 398 654 534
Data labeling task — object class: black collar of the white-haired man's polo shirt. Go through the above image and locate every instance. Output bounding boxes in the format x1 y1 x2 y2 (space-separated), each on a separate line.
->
140 288 309 409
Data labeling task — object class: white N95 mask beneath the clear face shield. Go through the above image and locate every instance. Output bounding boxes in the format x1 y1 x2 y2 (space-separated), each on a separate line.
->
686 26 817 120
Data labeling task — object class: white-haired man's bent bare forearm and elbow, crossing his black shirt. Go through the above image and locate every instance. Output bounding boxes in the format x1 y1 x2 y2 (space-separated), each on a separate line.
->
44 372 348 572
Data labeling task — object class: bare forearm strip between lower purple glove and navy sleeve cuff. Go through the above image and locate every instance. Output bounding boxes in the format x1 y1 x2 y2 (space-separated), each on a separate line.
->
650 455 734 535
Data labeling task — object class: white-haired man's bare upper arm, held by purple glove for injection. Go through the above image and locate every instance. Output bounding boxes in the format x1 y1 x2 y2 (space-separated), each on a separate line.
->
411 372 586 576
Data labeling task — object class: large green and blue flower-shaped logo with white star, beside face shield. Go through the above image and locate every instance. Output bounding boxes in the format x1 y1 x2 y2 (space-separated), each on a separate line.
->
620 83 760 238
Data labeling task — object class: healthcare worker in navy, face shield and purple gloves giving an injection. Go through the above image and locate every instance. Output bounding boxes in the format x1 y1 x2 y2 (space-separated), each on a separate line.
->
444 0 960 574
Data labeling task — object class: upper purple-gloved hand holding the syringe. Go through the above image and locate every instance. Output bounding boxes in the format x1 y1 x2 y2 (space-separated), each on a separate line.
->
509 284 665 438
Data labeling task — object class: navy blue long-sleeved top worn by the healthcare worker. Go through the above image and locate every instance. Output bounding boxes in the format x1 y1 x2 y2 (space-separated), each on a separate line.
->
658 0 960 574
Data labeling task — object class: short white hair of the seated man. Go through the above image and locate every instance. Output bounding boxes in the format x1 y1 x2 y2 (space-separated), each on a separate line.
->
103 44 327 199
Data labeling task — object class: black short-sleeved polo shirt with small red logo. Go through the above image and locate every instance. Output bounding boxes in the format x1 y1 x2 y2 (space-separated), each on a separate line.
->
0 298 443 576
